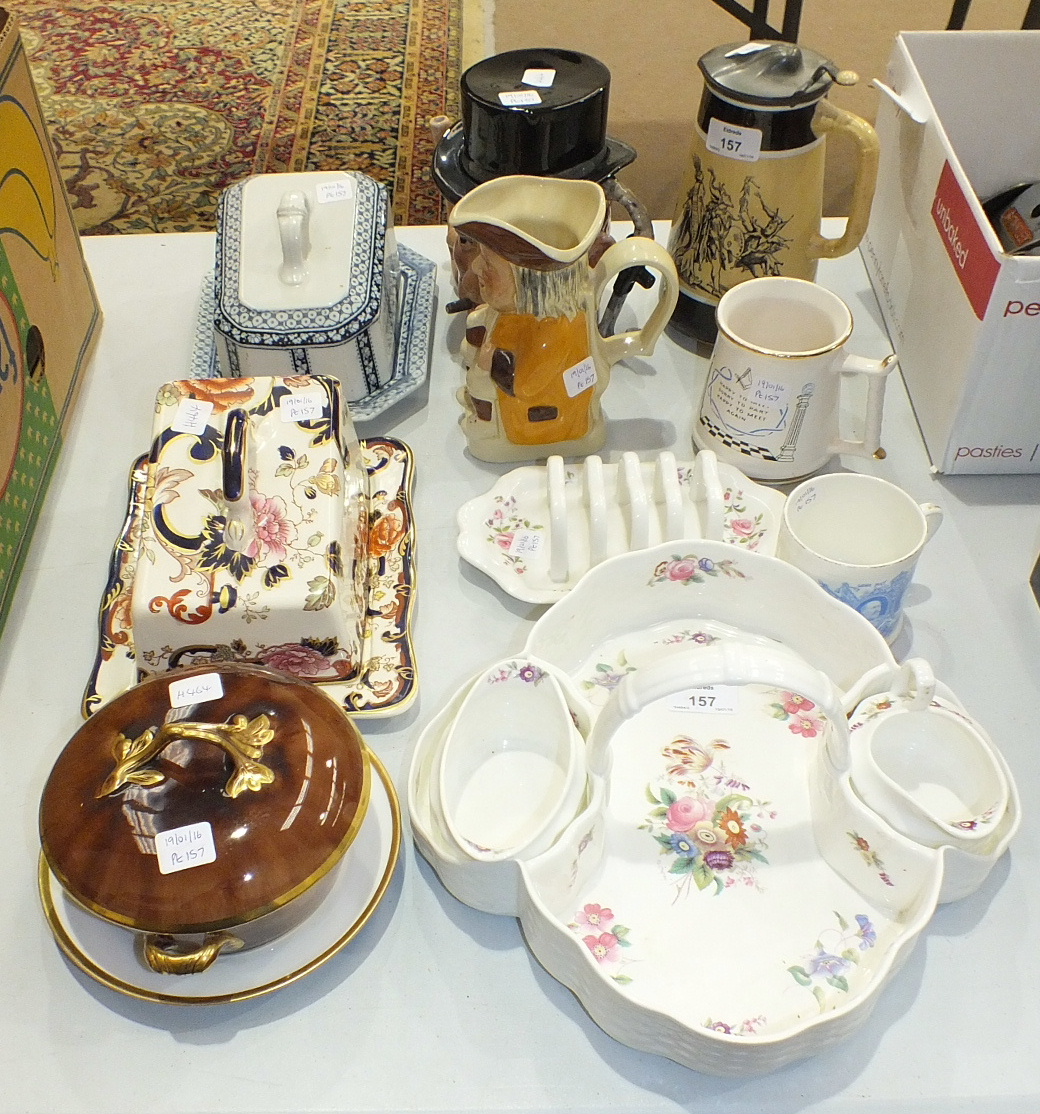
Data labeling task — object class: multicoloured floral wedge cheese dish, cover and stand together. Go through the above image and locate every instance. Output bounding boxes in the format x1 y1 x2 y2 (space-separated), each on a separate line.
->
84 377 415 714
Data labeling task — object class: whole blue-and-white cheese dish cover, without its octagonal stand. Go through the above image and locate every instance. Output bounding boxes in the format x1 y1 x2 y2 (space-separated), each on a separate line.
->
214 170 400 402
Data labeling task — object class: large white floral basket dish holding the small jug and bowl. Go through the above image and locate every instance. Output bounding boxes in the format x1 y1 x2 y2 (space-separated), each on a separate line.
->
409 539 1020 1075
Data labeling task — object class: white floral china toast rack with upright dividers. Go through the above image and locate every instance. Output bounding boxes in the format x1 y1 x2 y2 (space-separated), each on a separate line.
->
458 450 784 604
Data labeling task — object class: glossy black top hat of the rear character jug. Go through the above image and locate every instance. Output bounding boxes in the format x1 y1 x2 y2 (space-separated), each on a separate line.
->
433 48 636 204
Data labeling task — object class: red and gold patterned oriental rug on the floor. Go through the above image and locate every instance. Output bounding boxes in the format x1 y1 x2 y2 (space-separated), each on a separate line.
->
0 0 462 234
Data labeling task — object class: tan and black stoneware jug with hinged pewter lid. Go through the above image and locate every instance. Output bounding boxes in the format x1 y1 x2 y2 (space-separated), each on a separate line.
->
668 41 879 344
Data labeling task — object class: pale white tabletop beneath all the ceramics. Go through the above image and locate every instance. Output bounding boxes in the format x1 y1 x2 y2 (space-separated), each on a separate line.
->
0 221 1040 1114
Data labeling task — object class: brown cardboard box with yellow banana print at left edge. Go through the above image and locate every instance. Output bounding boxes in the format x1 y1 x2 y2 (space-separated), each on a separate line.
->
0 8 101 628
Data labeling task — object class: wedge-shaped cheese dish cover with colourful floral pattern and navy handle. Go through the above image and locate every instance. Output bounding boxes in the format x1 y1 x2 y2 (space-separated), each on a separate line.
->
130 375 369 681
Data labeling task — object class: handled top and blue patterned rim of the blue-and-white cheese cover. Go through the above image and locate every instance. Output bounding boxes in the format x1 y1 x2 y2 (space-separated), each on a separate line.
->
214 170 394 348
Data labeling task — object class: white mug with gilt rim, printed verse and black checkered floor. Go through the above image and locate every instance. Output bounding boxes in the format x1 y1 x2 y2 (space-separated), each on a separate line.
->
694 275 895 483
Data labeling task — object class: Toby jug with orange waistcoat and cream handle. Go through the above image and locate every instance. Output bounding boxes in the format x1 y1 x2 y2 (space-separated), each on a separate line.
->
449 175 678 462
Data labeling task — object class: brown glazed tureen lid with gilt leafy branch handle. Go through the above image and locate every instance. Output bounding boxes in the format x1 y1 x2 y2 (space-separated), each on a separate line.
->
40 663 371 934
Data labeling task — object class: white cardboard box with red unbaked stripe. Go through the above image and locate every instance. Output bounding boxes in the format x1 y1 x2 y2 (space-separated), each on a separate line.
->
861 31 1040 473
